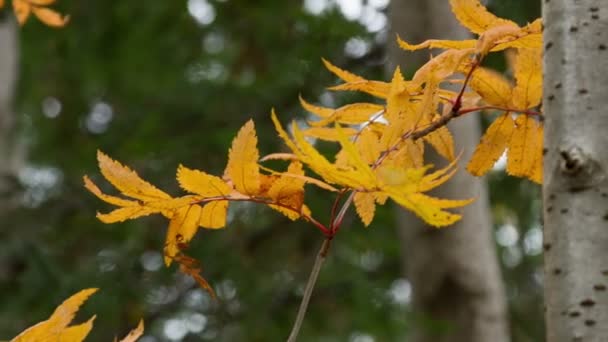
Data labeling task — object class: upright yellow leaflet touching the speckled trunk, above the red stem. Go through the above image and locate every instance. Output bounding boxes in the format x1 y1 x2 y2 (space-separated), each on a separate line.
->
512 49 543 109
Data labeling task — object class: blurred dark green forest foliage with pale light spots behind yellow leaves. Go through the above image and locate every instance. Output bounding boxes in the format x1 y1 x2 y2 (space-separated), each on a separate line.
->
0 0 544 342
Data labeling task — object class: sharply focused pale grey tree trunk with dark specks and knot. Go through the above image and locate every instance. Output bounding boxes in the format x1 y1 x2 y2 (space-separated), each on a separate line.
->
543 0 608 342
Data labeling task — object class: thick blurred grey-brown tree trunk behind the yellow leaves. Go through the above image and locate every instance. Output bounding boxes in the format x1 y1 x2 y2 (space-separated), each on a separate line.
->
388 0 509 342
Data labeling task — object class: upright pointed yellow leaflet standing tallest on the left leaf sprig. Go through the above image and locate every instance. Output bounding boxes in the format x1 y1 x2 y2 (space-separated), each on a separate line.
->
225 120 260 195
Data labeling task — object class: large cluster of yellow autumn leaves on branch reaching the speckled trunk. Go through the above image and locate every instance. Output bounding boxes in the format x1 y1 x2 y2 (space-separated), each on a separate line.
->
84 0 543 300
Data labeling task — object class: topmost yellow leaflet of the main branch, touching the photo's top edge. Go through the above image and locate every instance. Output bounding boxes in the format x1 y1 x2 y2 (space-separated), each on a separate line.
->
450 0 517 34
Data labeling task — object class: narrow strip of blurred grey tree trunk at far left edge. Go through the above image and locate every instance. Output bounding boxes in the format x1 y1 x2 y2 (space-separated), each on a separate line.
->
0 16 19 215
